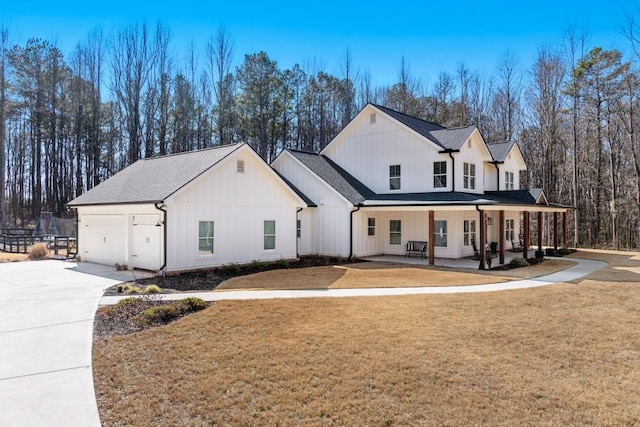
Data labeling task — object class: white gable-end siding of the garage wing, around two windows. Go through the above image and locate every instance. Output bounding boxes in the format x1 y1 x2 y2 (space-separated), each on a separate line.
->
166 147 300 271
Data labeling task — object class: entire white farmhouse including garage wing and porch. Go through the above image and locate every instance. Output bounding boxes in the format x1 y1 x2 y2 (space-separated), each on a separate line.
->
68 104 570 272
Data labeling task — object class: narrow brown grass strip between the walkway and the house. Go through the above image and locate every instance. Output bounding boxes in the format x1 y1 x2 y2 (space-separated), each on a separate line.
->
217 260 575 290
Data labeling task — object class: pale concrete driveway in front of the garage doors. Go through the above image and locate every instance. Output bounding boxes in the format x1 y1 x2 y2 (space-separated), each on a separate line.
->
0 260 151 426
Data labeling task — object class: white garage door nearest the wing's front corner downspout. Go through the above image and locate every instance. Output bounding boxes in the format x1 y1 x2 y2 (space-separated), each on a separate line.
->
132 215 162 271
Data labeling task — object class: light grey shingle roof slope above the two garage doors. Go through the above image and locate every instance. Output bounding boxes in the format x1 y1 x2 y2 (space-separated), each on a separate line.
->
68 144 242 206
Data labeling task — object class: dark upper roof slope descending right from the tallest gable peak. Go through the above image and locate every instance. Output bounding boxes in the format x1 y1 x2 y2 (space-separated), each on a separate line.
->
372 104 476 150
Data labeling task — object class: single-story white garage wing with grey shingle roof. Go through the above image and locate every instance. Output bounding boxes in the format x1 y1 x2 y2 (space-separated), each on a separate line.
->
68 144 309 272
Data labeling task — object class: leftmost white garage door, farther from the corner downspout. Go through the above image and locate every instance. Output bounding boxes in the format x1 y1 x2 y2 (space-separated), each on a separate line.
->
78 215 127 265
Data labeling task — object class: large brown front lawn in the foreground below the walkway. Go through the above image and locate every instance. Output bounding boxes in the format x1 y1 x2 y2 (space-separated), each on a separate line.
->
94 252 640 426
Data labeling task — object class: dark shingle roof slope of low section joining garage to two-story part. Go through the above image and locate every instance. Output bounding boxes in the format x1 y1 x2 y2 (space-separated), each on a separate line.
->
287 150 375 205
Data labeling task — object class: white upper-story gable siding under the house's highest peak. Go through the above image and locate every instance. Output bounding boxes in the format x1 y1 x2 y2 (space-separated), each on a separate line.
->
322 106 451 194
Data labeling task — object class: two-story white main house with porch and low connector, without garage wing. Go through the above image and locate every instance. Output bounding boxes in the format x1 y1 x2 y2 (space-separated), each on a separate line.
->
272 104 568 268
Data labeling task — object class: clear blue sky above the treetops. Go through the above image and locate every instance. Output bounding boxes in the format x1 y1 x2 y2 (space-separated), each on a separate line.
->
0 0 640 84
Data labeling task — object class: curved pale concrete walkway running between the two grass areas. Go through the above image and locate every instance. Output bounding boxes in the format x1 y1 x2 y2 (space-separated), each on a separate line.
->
100 258 607 305
